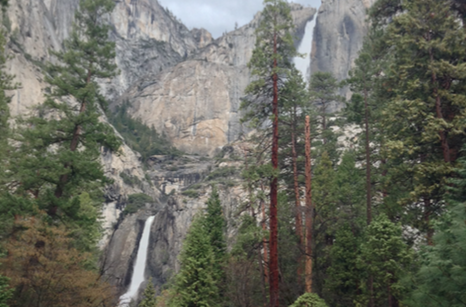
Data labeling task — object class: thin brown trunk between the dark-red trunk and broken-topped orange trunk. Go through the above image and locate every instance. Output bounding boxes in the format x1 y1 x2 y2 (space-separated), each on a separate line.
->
291 107 304 283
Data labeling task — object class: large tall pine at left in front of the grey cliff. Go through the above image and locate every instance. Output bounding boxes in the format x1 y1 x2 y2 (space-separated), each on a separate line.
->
2 0 120 253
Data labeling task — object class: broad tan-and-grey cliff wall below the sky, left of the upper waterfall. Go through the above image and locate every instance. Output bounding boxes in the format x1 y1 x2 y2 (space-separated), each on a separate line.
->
113 4 316 156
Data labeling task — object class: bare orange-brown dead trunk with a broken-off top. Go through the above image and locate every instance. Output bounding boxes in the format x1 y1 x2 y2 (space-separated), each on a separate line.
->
305 116 314 293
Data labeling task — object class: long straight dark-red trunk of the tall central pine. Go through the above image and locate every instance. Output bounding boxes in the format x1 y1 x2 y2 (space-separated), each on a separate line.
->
269 28 279 307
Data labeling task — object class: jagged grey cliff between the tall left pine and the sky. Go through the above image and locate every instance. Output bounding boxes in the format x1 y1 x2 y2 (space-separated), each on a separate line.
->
103 0 211 99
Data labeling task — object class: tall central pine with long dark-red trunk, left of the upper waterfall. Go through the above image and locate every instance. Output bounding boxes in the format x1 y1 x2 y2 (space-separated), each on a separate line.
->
242 0 297 307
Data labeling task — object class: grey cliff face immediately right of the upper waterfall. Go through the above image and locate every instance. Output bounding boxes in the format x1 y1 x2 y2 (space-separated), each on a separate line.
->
311 0 375 103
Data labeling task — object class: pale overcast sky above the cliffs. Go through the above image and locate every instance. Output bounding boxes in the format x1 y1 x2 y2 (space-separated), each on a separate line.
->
159 0 321 38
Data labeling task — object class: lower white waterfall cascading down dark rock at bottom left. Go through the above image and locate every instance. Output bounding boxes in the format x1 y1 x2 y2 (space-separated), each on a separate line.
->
120 216 155 307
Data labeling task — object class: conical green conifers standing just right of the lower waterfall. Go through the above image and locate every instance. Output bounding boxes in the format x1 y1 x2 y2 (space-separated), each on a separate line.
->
161 187 226 307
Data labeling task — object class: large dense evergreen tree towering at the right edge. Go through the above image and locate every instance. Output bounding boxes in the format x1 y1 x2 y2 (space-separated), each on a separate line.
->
382 0 466 243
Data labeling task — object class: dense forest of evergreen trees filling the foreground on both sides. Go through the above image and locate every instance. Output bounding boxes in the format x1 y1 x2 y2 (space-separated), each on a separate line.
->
0 0 466 307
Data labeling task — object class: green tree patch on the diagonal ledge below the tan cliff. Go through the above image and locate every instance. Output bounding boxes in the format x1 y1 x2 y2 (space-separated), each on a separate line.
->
107 102 183 163
